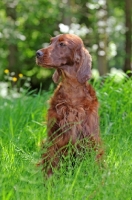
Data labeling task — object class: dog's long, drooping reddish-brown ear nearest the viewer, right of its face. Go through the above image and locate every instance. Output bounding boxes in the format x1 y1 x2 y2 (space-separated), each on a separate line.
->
77 47 92 84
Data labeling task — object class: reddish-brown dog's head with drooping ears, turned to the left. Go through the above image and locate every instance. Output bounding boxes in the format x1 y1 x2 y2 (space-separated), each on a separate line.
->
36 34 92 84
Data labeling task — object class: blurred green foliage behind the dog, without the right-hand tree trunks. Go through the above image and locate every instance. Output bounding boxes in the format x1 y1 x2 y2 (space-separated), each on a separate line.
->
0 0 129 89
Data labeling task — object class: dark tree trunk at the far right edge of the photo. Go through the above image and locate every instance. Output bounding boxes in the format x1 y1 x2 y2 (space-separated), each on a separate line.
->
124 0 132 76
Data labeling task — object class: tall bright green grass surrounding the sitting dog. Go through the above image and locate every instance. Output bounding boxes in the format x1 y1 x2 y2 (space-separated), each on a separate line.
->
0 77 132 200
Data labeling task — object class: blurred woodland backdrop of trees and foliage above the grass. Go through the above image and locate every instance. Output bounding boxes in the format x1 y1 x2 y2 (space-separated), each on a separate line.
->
0 0 132 90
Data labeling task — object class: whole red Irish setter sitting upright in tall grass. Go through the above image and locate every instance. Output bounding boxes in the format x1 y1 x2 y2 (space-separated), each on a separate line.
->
36 34 103 176
